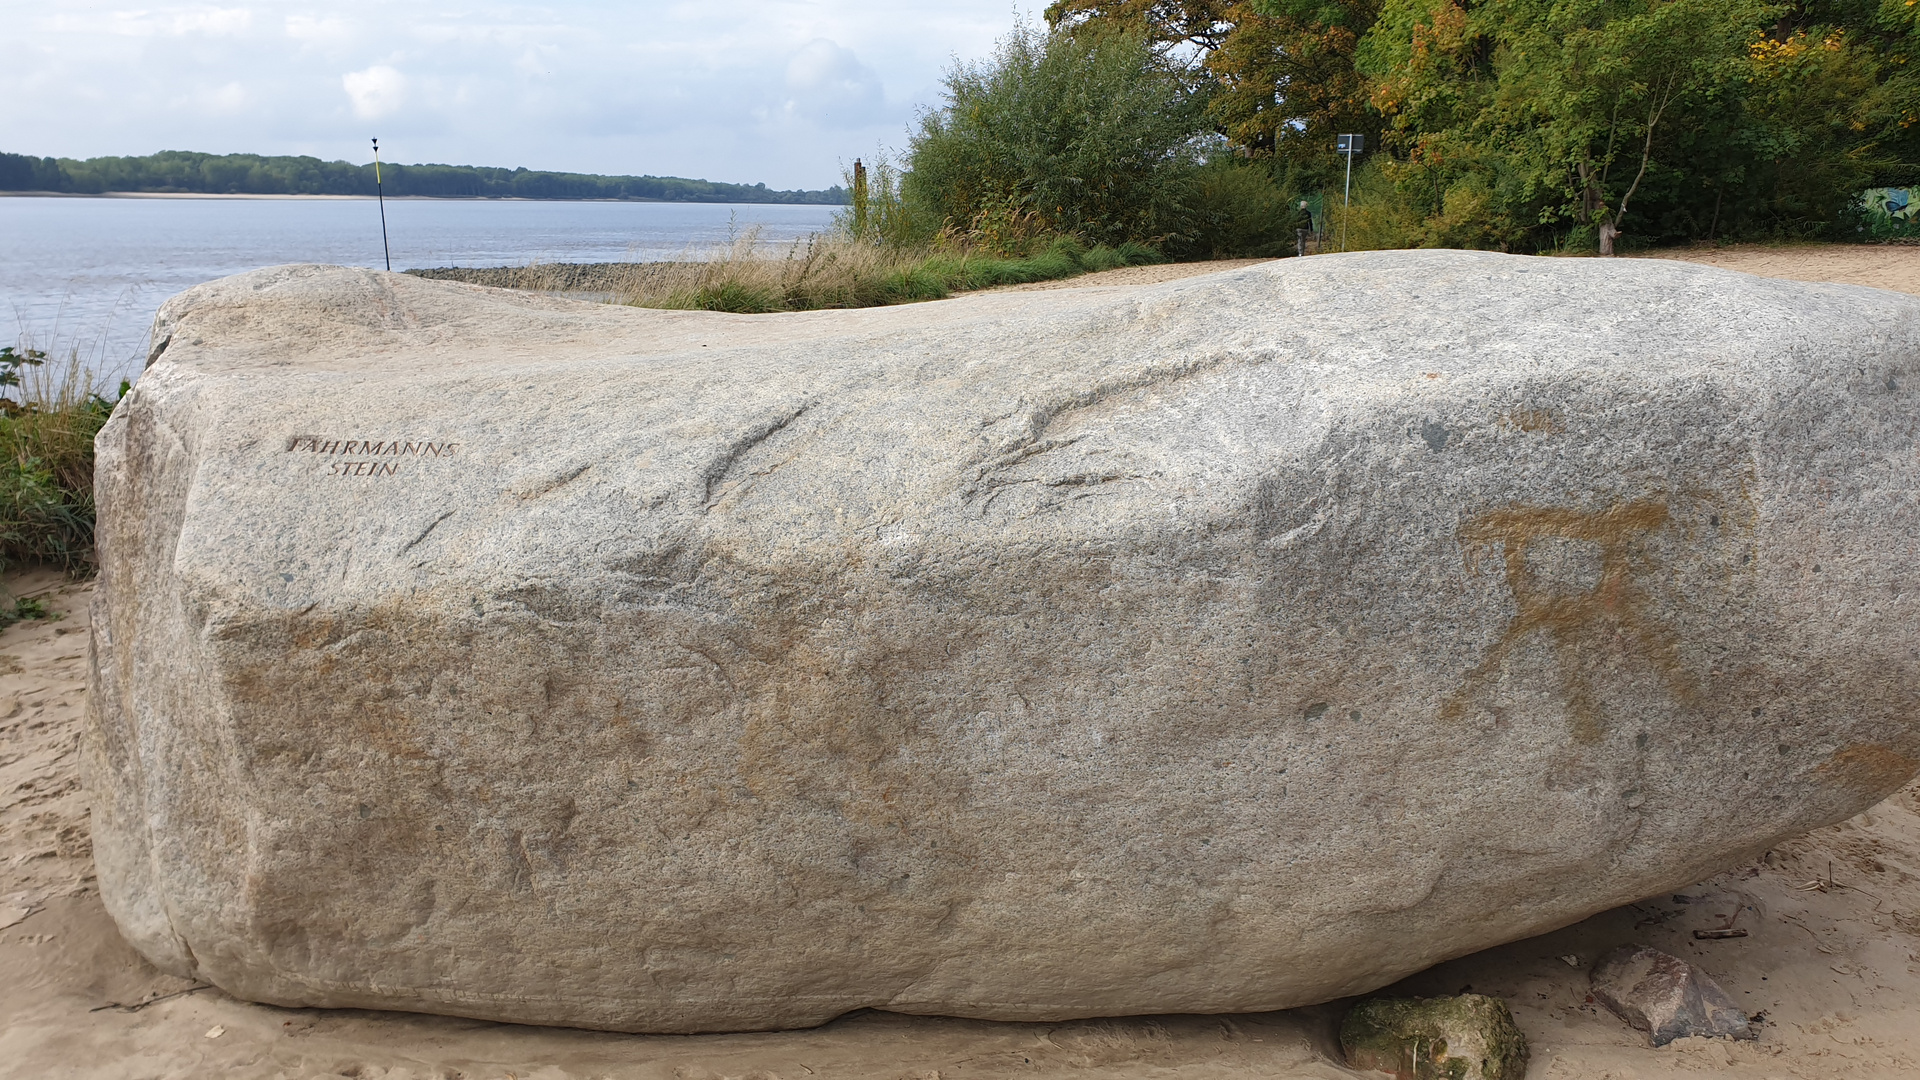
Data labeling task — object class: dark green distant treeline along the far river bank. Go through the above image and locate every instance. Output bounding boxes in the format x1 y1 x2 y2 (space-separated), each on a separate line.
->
0 150 847 206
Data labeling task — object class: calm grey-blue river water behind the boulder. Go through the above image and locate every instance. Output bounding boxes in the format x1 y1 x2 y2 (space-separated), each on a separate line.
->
0 196 835 386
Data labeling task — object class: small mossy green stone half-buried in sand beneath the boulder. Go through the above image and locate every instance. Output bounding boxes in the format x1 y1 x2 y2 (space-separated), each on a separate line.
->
1340 994 1528 1080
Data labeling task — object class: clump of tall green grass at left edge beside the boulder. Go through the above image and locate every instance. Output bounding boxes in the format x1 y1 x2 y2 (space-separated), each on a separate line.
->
0 344 127 577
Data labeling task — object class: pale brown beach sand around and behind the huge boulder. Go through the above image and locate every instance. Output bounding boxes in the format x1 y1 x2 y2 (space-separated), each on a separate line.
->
0 246 1920 1080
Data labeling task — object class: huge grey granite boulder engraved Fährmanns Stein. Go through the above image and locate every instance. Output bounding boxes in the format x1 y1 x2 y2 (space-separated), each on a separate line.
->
88 252 1920 1032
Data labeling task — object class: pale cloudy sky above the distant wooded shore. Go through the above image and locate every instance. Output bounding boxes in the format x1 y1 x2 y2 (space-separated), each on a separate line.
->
0 0 1035 188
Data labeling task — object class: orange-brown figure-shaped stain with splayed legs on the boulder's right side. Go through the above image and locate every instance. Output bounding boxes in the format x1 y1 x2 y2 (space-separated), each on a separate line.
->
1440 500 1695 744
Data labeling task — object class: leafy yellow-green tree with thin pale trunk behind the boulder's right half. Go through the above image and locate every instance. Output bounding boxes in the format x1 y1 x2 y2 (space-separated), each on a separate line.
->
1359 0 1784 254
